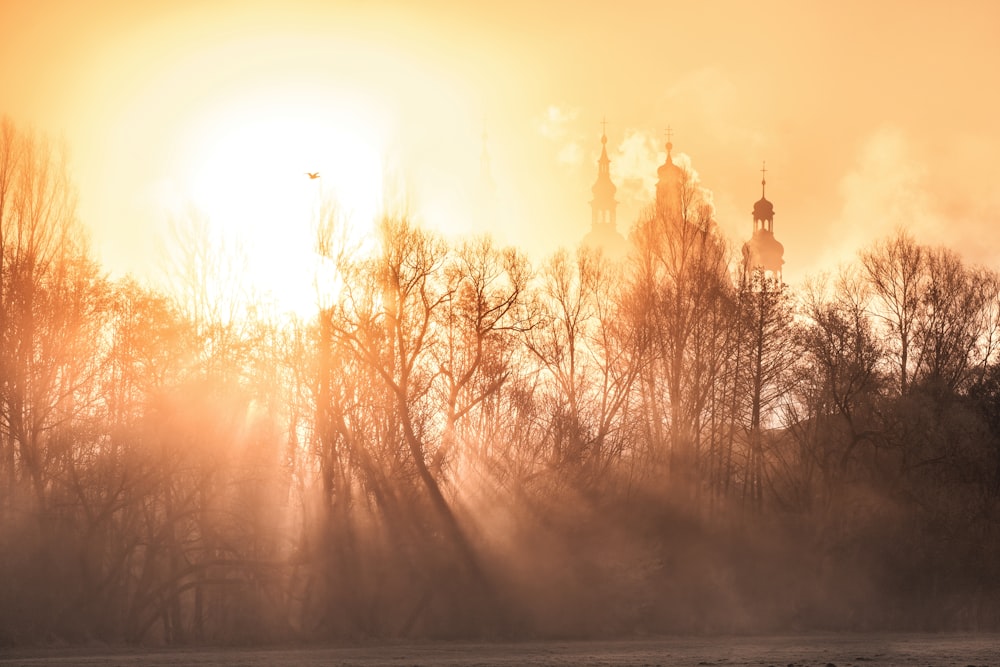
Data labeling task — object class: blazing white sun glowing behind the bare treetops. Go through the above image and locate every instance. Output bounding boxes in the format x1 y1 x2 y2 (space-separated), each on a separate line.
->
172 89 385 314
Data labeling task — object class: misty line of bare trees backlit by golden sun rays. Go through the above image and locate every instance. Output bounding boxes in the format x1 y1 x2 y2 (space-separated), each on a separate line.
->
0 120 1000 645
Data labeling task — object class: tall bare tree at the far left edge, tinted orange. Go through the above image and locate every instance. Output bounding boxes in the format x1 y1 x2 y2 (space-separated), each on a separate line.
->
0 119 98 508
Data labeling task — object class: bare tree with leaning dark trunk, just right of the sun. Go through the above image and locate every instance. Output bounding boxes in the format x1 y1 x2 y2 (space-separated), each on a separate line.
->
320 217 498 632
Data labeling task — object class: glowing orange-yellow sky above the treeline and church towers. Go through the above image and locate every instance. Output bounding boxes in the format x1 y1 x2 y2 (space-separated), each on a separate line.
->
0 0 1000 302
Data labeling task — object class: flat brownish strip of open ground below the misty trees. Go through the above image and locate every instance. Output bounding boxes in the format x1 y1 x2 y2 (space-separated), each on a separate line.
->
0 634 1000 667
